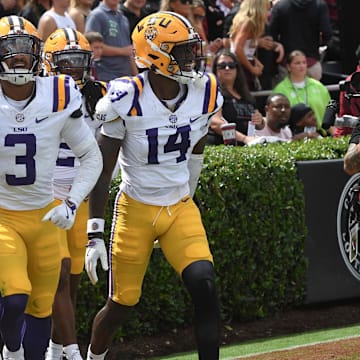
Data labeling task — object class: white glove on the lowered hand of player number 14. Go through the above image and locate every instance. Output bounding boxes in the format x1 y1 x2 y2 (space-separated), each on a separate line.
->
85 238 109 285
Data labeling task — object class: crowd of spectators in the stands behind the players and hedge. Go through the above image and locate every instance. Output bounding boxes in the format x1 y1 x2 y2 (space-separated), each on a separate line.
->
4 0 360 145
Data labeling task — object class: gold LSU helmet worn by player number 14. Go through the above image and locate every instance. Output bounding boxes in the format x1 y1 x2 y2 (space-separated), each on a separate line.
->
131 11 203 84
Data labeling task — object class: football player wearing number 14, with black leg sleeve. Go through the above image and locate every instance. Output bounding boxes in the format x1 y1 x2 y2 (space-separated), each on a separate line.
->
85 12 223 360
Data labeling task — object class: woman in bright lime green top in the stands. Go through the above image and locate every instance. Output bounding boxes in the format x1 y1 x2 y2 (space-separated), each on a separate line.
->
273 50 330 130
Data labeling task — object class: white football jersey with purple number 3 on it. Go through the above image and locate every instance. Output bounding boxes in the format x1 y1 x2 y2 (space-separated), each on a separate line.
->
0 75 92 210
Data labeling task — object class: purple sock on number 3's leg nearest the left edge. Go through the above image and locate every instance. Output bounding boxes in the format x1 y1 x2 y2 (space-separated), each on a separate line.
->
0 294 28 351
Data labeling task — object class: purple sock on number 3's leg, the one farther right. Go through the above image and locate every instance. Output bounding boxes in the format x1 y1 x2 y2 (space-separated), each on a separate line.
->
23 314 51 360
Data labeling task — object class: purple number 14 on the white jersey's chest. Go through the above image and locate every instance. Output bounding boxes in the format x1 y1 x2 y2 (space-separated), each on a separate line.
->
146 125 191 164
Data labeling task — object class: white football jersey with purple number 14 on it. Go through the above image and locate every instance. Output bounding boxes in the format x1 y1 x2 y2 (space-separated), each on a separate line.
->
96 71 223 206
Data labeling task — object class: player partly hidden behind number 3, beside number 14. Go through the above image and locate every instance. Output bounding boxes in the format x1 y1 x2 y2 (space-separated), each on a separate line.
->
43 28 106 360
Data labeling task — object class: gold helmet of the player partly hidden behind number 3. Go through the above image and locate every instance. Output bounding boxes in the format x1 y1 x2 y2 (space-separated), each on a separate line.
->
43 28 92 88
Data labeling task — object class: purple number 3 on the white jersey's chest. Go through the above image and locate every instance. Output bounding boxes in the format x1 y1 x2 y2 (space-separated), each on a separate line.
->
5 134 36 186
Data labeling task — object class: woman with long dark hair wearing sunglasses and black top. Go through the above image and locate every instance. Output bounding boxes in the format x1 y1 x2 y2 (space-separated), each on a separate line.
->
207 49 264 145
